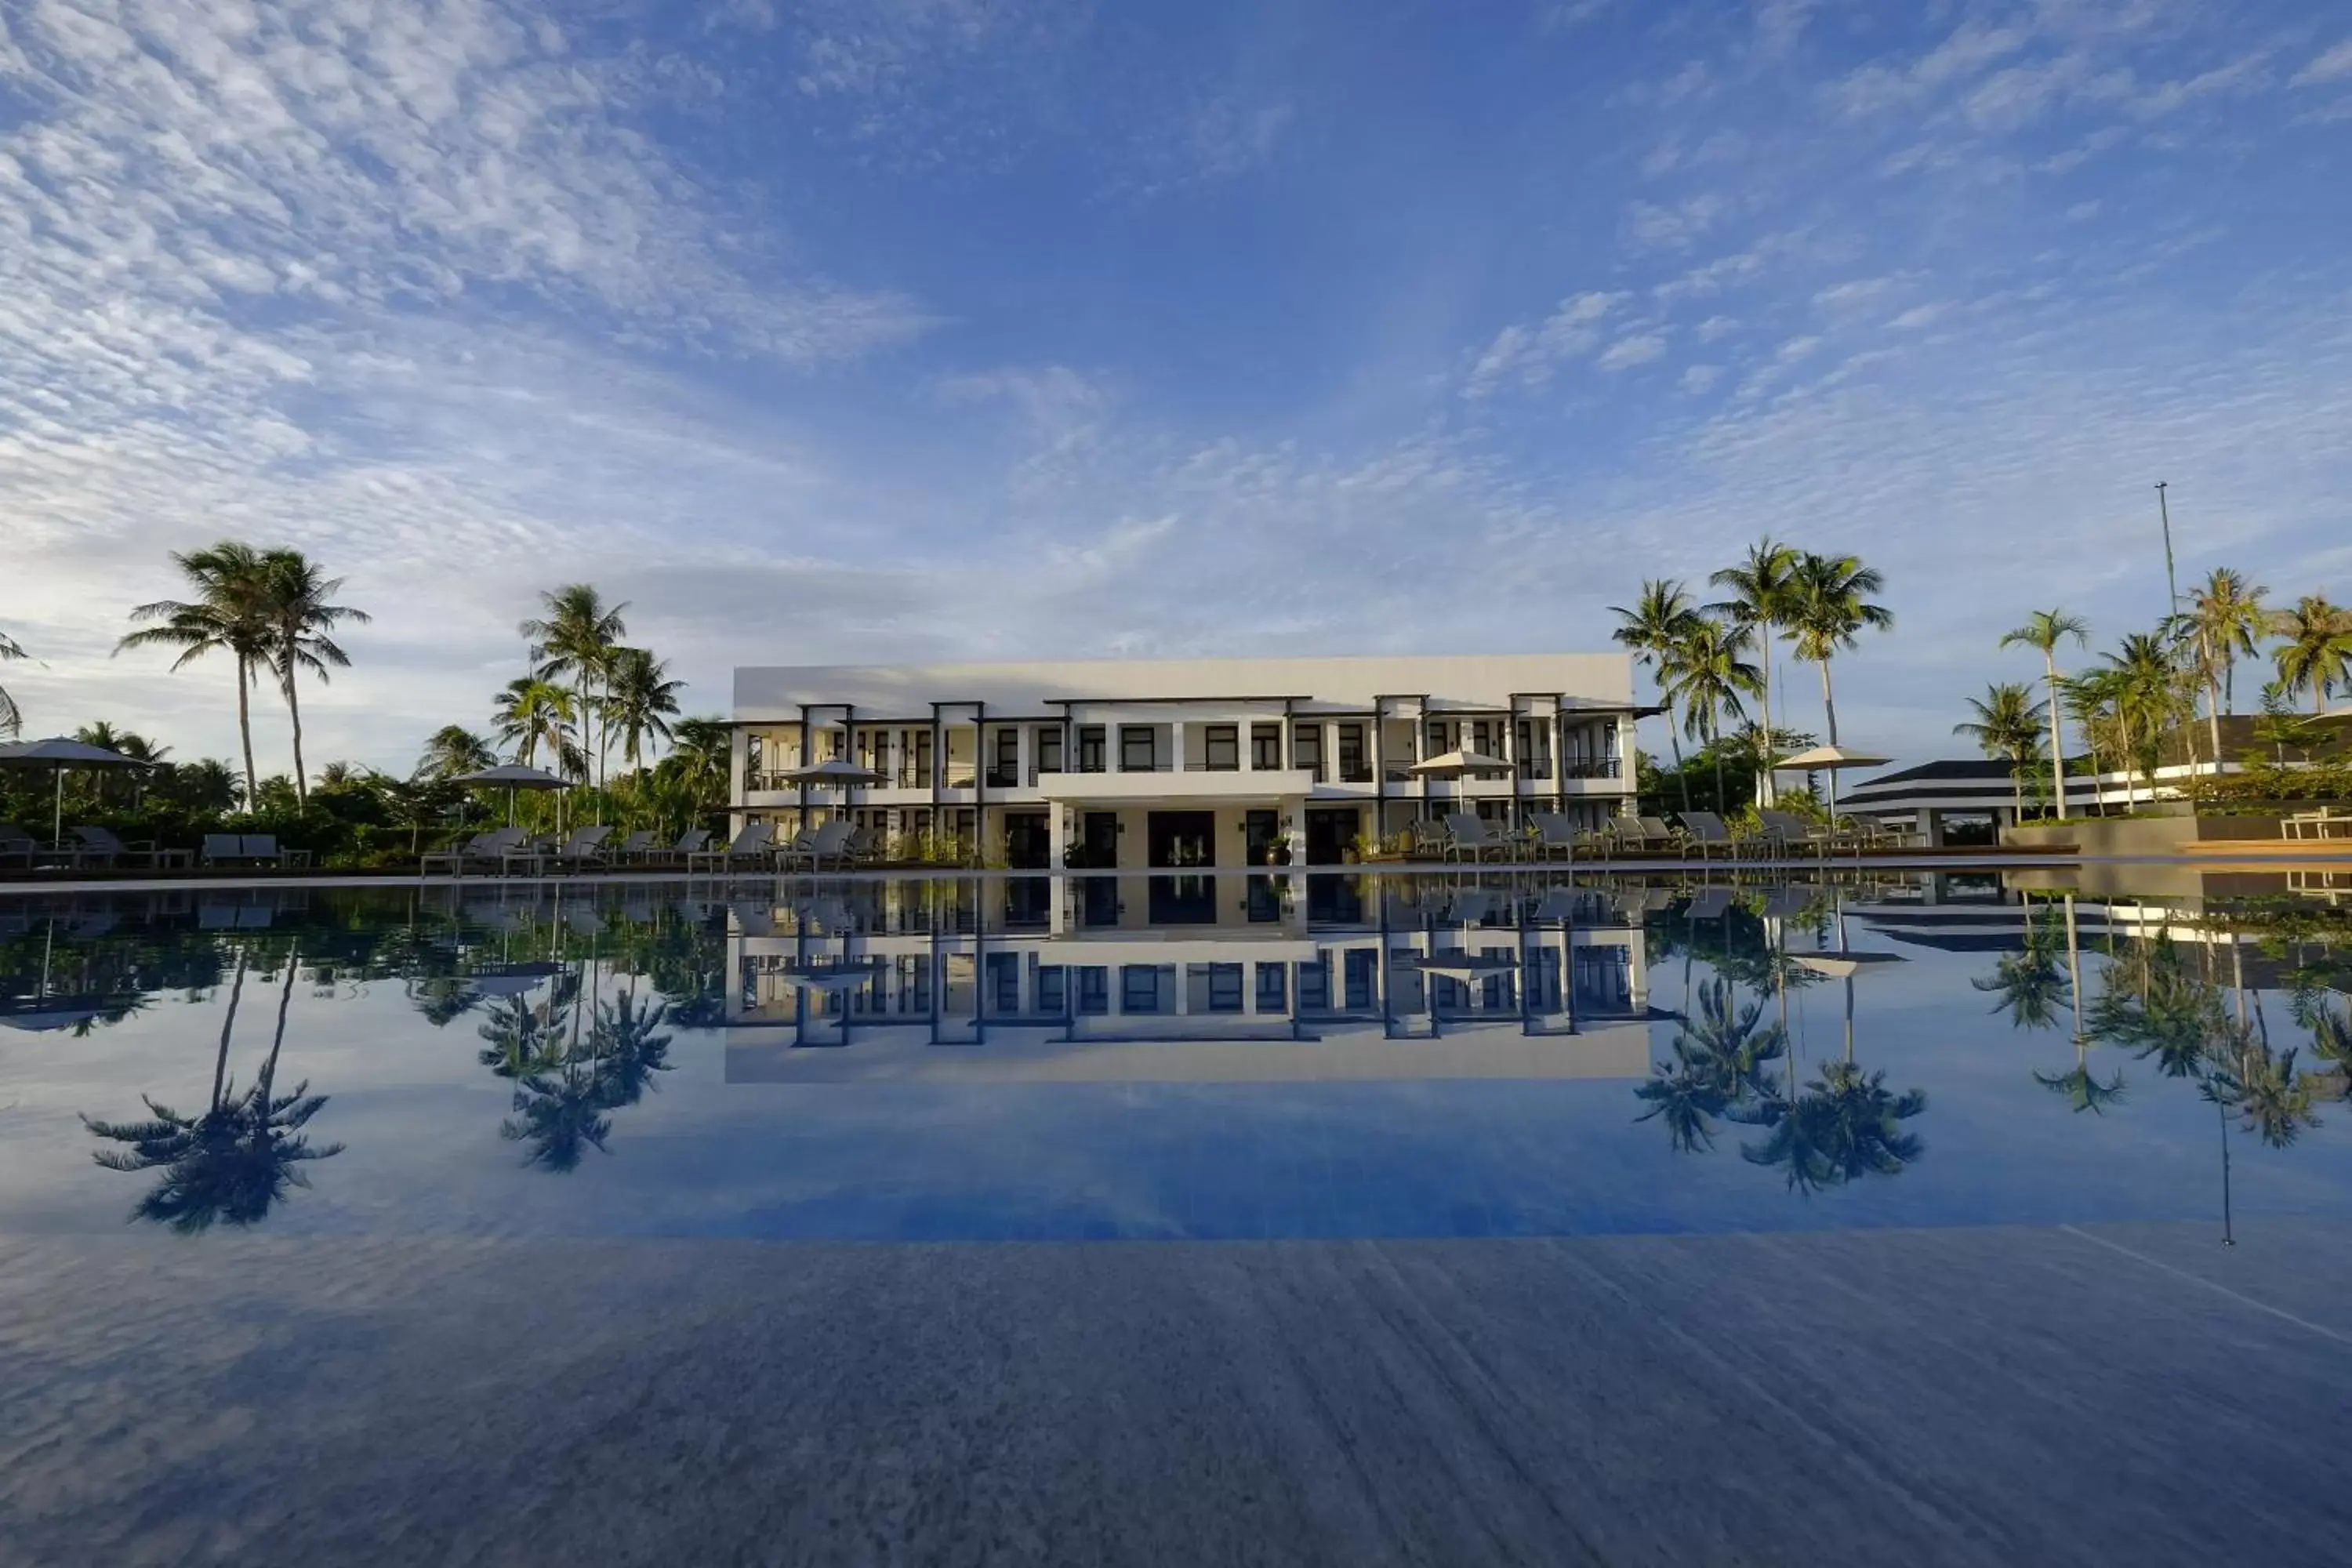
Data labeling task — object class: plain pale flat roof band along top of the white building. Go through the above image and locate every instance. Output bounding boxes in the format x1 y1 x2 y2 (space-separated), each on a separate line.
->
734 654 1632 722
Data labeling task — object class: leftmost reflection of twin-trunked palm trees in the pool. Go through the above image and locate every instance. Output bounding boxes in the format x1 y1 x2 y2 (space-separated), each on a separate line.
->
82 949 343 1234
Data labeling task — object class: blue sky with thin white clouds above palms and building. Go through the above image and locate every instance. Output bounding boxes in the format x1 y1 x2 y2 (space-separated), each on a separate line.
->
0 0 2352 767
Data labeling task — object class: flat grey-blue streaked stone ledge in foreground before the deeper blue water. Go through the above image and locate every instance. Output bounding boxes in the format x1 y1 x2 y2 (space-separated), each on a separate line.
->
0 1222 2352 1568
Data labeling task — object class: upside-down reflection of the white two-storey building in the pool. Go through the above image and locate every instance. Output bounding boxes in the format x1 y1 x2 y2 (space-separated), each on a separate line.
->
727 872 1649 1081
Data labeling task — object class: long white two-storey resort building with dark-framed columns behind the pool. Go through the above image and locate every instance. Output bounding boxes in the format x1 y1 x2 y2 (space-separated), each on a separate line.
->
731 654 1639 869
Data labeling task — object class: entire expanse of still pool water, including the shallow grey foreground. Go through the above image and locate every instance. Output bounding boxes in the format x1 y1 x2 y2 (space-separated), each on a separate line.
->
0 867 2352 1561
